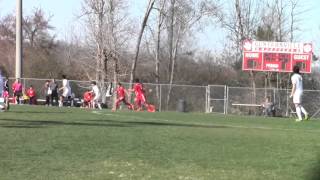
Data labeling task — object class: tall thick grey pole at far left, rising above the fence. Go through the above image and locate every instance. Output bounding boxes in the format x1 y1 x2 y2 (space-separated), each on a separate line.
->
16 0 22 78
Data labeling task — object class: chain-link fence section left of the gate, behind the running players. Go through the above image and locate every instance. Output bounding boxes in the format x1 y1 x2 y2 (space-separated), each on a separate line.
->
9 78 207 112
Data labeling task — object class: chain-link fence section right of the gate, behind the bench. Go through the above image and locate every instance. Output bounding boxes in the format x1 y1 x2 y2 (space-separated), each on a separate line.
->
227 87 320 117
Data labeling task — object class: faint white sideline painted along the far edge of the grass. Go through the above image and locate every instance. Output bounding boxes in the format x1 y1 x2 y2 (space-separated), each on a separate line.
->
92 111 320 133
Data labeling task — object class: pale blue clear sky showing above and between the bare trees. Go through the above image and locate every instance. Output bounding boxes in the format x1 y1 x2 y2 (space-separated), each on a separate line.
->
0 0 320 52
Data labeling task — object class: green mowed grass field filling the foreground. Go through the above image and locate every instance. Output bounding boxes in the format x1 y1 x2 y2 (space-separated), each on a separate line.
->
0 106 320 180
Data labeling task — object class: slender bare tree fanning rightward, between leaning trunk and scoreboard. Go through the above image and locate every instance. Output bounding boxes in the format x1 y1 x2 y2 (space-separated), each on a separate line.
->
166 0 218 108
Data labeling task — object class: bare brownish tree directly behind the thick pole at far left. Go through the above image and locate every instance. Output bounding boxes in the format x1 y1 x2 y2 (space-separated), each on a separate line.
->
0 9 59 78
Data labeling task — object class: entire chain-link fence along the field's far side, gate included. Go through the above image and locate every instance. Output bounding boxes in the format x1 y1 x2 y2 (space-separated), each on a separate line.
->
9 78 320 116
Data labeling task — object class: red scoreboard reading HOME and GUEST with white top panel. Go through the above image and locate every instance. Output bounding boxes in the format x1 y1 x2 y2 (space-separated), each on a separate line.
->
242 40 313 73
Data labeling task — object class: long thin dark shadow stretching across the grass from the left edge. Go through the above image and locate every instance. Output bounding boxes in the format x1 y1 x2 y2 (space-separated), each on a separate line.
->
0 119 230 128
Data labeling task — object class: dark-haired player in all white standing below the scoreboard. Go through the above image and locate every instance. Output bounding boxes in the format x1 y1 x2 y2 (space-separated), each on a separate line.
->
290 66 309 122
